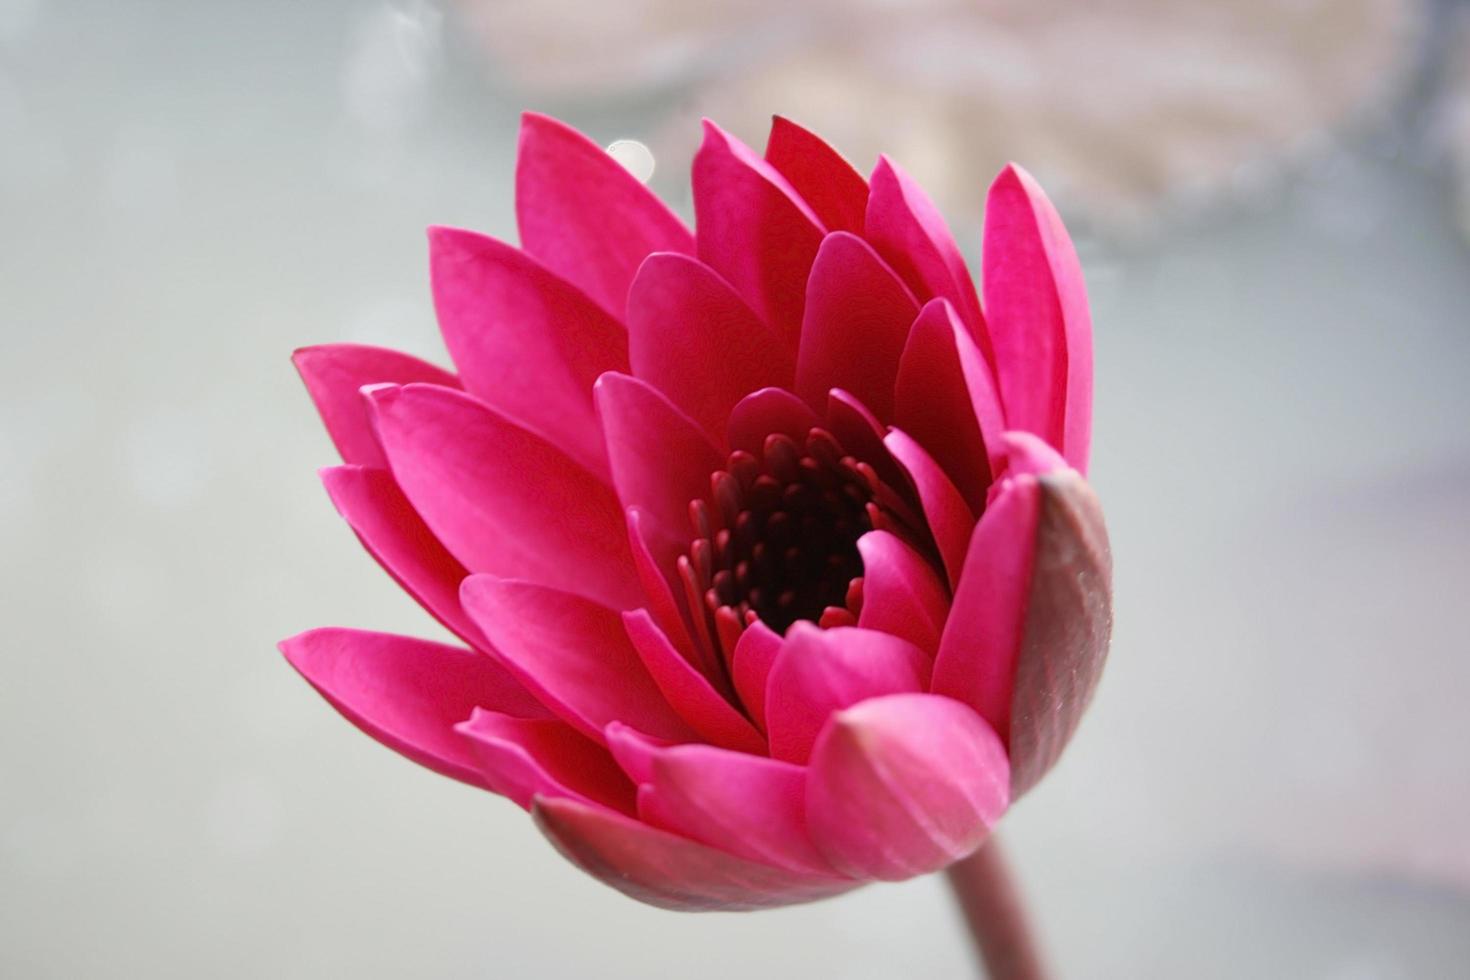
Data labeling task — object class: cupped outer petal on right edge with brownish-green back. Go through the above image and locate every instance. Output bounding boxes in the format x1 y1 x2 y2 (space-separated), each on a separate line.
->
932 470 1113 798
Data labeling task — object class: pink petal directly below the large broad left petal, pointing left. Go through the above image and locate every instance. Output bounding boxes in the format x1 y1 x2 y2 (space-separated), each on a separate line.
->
460 574 694 742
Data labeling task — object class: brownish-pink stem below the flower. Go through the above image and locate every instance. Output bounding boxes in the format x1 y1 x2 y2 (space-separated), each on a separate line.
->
945 837 1048 980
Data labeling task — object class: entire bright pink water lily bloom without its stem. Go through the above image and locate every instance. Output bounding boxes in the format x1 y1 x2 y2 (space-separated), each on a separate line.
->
282 115 1111 909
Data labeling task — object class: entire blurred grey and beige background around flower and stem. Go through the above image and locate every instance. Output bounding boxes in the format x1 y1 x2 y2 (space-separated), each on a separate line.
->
0 0 1470 980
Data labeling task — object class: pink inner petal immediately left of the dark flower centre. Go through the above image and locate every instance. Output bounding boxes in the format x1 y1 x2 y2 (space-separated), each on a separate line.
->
595 373 725 582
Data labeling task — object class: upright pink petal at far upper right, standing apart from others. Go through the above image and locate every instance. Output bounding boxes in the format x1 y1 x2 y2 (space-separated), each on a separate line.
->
983 163 1092 473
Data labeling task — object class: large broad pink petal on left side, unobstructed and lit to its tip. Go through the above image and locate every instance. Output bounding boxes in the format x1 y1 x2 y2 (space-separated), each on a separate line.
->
370 385 639 608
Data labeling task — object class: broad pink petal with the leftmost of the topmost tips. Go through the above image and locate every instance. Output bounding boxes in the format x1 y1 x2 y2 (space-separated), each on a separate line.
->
516 112 694 319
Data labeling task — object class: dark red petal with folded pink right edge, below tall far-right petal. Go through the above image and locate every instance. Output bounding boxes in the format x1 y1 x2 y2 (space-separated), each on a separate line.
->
894 300 1005 514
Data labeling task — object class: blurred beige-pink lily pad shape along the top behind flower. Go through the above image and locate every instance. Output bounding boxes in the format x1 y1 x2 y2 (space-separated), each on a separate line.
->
463 0 1421 232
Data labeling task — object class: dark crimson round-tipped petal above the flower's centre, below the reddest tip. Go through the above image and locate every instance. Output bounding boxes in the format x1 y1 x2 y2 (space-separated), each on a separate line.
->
797 232 919 420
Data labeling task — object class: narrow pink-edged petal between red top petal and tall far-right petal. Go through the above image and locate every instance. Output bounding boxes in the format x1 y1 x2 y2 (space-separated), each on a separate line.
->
864 157 991 361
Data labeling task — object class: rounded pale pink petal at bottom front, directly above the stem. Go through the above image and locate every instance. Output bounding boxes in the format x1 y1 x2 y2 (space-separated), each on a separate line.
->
807 693 1010 882
